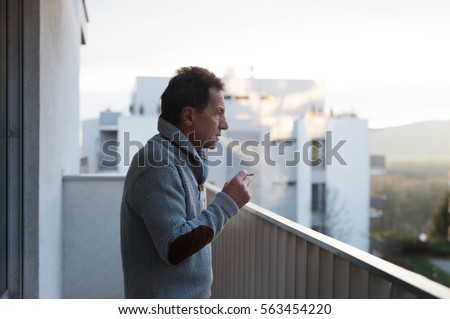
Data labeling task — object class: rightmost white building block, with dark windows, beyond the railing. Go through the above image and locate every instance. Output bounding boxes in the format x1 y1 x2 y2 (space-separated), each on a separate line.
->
295 114 370 251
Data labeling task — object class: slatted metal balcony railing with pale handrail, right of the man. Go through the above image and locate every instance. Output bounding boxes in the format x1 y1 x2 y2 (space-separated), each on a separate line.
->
207 185 450 299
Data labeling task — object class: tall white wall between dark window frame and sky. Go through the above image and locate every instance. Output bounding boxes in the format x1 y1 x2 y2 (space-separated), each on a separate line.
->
36 0 82 298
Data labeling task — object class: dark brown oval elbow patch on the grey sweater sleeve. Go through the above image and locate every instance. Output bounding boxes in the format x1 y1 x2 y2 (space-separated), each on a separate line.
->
168 226 214 265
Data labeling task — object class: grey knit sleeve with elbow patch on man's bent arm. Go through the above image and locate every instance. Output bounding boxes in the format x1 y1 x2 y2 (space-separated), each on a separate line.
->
128 164 238 265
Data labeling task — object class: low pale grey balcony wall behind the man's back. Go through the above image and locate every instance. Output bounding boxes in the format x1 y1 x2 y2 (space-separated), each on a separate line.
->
62 174 125 299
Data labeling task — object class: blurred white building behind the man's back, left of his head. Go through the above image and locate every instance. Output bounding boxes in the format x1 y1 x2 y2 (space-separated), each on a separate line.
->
81 77 170 174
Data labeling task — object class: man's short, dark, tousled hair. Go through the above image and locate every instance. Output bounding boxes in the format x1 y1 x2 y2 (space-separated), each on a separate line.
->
161 66 225 125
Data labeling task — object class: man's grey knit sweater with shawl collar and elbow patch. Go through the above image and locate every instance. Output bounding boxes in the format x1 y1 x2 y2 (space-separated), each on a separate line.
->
121 118 238 298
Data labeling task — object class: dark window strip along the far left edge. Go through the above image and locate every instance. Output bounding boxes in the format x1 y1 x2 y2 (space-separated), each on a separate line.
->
0 0 25 298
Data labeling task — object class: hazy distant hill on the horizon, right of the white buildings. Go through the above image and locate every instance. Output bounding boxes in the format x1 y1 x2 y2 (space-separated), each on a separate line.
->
370 120 450 161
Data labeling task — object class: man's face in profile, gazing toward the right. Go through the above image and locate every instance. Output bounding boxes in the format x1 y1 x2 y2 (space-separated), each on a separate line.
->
190 88 228 149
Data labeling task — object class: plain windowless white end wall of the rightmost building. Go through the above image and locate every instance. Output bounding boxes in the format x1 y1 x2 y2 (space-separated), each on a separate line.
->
325 117 370 252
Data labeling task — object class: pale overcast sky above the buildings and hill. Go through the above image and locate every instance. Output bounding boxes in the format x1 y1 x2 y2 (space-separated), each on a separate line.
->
80 0 450 128
